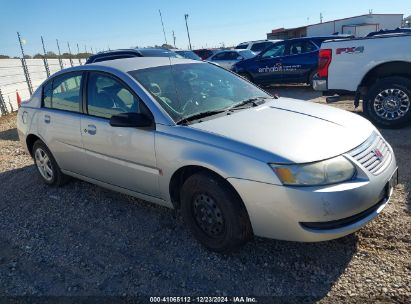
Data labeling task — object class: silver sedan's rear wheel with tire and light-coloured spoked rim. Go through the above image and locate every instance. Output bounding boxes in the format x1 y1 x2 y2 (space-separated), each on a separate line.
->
32 140 69 187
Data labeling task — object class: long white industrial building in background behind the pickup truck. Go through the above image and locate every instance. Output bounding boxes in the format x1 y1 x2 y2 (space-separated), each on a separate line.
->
267 14 404 39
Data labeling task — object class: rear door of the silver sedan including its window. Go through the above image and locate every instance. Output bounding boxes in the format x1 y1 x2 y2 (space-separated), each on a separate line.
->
38 72 86 174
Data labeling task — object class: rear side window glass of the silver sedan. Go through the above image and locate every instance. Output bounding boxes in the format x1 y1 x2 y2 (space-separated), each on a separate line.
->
43 73 82 112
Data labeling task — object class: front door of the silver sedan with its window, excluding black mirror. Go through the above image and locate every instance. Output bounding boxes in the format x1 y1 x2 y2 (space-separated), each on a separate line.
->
81 72 160 197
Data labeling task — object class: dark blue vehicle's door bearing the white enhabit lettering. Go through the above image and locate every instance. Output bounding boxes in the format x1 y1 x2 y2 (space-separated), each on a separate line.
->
252 42 285 83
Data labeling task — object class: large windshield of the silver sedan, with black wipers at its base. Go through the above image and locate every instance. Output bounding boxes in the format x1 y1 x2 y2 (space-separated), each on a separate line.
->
129 63 271 122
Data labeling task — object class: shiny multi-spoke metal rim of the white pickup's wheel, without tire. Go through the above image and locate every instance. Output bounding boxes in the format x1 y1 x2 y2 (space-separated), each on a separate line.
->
374 89 410 120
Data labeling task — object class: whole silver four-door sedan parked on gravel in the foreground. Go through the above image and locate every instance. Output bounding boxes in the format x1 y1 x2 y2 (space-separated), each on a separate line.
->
17 58 397 252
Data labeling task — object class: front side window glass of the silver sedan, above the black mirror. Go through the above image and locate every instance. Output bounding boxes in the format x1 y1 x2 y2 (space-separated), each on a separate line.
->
87 72 141 119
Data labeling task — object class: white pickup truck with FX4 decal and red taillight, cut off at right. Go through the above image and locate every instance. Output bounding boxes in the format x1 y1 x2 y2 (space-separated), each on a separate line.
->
313 32 411 128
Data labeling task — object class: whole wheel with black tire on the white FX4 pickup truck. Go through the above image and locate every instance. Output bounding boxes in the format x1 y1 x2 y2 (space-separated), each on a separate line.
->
363 77 411 128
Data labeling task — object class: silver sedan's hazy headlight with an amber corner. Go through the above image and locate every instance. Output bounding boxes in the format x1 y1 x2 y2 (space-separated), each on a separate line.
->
270 156 355 186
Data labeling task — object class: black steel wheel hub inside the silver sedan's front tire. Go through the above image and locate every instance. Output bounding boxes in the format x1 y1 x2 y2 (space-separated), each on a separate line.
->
193 194 225 237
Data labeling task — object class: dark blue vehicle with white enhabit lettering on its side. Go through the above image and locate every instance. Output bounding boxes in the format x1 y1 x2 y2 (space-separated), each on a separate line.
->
233 35 347 85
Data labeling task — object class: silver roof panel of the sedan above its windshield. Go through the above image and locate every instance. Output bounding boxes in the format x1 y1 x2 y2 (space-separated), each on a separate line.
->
88 57 203 73
